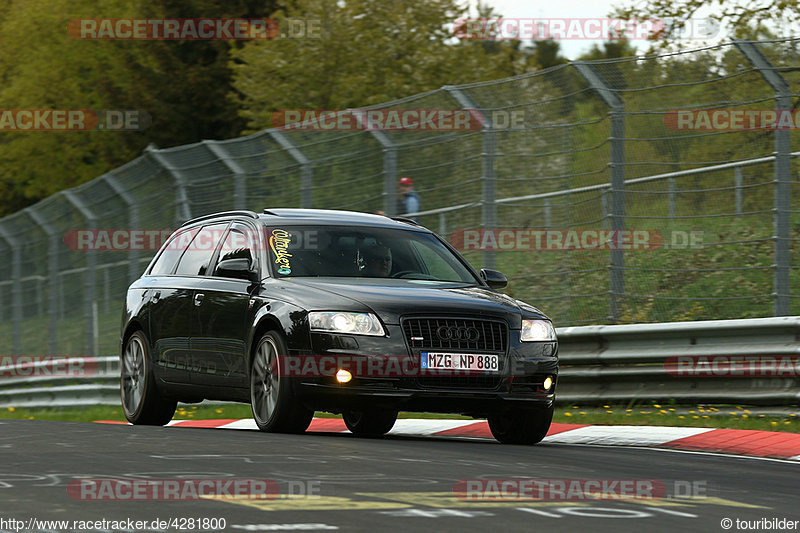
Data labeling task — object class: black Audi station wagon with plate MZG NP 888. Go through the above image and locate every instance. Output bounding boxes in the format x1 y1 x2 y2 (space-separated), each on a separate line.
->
120 209 558 444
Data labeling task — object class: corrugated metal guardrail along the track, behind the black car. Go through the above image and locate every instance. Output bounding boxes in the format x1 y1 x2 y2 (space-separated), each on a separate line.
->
0 316 800 408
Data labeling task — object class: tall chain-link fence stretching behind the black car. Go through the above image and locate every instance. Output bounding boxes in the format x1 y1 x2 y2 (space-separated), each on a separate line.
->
0 36 800 355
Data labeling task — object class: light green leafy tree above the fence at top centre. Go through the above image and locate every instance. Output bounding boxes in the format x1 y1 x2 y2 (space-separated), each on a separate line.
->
233 0 515 130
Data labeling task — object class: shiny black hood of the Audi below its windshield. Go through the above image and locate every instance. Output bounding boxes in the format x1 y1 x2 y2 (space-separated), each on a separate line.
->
272 278 546 329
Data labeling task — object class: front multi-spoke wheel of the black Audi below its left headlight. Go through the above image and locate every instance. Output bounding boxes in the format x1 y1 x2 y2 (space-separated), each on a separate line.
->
250 331 314 433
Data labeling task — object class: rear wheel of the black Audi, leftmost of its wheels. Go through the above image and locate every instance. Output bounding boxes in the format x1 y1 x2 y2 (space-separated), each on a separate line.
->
119 330 178 426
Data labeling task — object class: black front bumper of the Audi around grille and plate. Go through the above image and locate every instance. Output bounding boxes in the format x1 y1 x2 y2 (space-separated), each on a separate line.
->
293 326 558 416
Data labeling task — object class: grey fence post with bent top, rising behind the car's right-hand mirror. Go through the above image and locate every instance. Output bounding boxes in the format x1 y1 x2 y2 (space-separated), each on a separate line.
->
442 85 497 268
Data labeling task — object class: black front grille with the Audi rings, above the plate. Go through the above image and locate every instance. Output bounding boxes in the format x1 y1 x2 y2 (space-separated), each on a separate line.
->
403 318 508 354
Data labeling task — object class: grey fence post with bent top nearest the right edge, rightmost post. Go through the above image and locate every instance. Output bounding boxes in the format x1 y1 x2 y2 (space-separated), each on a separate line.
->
734 40 792 316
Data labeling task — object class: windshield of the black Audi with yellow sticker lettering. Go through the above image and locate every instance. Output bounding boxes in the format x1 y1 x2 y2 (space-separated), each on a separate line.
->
267 226 477 284
